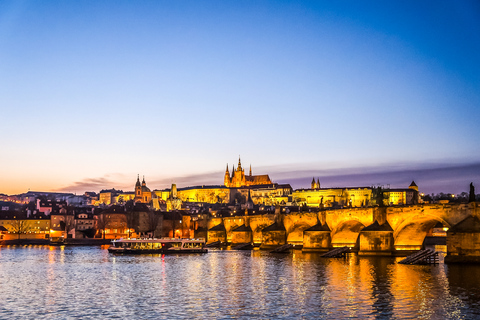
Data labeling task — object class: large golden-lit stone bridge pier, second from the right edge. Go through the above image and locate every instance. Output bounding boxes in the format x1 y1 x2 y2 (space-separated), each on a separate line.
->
358 221 394 256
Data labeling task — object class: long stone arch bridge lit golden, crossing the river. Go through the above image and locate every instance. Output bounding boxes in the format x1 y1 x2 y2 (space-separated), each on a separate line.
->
205 202 480 262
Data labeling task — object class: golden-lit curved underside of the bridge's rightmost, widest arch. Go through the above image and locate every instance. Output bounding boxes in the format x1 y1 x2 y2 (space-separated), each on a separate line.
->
393 214 451 250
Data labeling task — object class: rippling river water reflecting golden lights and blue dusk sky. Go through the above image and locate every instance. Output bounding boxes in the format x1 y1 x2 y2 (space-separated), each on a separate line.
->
0 246 480 319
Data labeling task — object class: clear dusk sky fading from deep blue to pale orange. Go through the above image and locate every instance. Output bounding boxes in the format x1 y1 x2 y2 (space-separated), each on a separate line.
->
0 0 480 194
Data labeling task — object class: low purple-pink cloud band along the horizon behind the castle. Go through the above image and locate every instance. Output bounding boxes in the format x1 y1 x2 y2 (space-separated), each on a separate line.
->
57 162 480 193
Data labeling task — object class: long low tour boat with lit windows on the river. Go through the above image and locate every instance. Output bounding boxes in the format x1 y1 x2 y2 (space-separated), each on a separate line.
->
108 238 208 254
